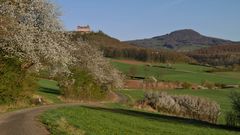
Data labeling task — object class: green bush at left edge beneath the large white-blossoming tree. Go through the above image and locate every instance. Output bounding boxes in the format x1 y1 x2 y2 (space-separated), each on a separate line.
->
0 55 36 104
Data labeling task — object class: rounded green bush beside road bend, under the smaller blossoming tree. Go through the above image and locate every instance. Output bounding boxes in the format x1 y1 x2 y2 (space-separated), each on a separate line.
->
60 68 108 100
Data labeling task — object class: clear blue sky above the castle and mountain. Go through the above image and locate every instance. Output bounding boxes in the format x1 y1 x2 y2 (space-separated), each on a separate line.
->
54 0 240 41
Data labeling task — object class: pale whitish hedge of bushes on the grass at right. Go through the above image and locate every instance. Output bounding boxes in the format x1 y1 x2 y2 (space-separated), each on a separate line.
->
141 93 220 123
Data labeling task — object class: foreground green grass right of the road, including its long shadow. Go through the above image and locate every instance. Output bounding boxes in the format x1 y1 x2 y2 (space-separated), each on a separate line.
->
41 106 239 135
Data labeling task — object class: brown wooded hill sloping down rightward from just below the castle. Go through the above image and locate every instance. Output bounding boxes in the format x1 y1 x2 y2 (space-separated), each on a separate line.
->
69 32 190 62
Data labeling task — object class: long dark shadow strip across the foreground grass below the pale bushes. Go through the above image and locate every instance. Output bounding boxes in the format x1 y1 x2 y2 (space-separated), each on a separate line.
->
83 106 240 131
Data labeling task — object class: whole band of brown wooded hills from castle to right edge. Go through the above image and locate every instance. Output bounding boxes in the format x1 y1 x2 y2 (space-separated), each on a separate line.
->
69 32 240 65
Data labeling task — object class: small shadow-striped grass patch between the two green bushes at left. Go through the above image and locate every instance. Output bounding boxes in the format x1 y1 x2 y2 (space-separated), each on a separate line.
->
37 79 61 103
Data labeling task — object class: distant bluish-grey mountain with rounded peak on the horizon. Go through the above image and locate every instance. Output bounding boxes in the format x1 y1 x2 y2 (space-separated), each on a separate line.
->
126 29 239 51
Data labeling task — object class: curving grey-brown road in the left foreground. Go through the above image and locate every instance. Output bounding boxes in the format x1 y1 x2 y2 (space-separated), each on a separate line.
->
0 104 82 135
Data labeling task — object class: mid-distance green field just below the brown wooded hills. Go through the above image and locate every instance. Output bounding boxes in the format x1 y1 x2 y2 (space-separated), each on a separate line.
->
111 61 240 84
